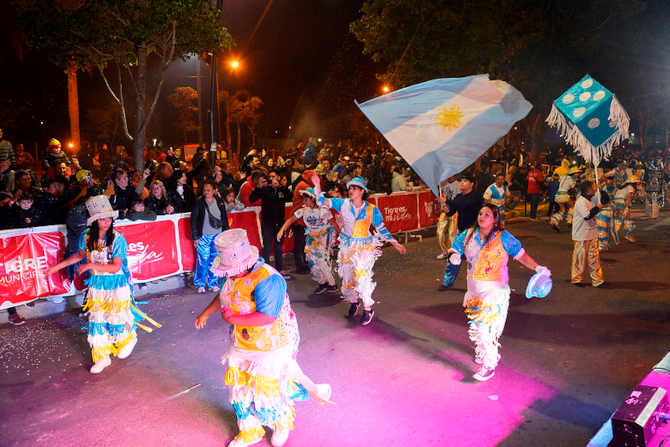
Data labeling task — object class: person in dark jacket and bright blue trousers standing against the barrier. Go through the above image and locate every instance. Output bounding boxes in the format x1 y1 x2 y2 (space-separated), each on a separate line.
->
191 180 229 293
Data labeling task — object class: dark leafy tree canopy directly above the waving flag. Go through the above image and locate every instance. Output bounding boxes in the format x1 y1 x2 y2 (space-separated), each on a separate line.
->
350 0 646 152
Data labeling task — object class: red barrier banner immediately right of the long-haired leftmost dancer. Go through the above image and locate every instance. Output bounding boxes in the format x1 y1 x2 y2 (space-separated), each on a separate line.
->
116 220 179 281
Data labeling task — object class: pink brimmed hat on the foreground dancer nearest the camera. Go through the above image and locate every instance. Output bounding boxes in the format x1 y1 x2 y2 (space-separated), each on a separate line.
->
210 228 258 277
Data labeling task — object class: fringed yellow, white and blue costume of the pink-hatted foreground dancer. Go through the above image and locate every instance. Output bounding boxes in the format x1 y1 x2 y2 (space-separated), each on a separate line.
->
219 258 330 445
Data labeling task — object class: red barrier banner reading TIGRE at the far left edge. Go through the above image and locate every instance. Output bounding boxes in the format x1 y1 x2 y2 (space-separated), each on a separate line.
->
0 231 70 304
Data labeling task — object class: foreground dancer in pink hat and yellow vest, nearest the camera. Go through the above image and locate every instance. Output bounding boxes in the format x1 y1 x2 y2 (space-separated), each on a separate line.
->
195 228 331 447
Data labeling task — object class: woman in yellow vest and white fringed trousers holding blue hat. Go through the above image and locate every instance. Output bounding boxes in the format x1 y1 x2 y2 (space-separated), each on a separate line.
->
449 203 551 381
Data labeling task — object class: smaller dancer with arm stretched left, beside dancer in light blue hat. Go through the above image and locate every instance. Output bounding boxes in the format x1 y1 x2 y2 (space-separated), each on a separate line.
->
277 187 337 295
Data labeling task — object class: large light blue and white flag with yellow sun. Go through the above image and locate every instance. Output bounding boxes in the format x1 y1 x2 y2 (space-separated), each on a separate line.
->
356 74 533 195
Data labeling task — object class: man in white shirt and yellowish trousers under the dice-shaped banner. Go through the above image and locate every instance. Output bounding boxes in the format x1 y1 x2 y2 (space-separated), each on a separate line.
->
570 181 609 287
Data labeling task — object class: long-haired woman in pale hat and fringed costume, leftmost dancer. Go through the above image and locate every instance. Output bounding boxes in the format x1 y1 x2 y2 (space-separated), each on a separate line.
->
47 195 160 374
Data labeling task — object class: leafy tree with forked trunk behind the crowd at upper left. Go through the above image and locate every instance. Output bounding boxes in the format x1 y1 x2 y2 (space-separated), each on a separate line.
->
18 0 232 169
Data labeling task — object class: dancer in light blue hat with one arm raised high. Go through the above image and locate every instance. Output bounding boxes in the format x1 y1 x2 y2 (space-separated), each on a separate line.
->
312 175 405 325
